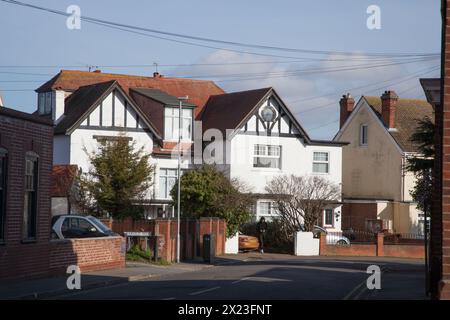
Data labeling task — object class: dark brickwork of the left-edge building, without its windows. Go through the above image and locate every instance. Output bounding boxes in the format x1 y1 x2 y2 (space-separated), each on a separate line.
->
0 108 53 280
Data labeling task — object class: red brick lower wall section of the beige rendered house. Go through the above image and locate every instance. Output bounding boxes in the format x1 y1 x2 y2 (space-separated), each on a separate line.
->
342 203 377 231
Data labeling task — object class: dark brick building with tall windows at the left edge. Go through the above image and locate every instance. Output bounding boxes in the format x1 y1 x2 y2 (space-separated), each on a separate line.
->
0 107 53 280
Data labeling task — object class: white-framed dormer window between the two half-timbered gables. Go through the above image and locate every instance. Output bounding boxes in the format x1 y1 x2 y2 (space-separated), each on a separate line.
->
164 107 192 140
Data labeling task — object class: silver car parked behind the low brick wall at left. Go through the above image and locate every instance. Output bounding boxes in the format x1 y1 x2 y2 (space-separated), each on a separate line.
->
52 215 118 239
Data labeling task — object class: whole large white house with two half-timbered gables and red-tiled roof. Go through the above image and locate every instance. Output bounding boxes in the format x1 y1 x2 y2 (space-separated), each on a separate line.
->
36 70 344 230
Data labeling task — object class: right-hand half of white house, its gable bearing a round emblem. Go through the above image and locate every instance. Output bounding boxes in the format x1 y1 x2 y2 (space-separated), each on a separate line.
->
202 88 345 230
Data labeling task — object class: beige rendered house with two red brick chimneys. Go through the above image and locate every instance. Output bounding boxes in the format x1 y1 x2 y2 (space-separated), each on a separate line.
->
334 91 434 236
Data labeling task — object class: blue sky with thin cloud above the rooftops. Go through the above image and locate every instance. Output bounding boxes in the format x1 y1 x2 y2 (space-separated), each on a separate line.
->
0 0 441 138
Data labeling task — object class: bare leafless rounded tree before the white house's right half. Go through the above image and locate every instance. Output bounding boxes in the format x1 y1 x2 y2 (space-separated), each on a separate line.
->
266 175 341 236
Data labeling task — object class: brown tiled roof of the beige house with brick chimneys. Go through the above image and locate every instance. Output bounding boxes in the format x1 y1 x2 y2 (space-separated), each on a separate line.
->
358 96 434 152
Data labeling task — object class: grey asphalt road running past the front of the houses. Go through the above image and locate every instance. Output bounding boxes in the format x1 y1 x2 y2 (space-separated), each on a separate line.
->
54 254 426 300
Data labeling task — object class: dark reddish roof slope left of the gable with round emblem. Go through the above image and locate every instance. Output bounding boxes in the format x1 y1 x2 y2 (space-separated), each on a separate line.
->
201 88 272 133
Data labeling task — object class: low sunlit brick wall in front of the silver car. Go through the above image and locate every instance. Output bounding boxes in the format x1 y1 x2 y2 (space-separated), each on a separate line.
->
49 237 125 274
